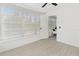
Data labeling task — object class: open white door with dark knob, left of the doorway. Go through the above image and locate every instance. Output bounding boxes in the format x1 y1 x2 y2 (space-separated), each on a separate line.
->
40 14 48 39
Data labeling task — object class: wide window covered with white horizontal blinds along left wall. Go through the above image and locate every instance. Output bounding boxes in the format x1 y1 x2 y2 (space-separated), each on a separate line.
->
0 6 40 39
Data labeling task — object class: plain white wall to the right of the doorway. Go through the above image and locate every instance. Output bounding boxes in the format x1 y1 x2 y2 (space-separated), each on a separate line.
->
57 3 79 47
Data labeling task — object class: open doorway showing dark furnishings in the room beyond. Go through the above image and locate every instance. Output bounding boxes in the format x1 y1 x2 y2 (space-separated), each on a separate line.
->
48 15 57 39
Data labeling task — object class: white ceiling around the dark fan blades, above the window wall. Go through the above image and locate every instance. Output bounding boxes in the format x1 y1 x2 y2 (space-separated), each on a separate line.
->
15 3 57 13
